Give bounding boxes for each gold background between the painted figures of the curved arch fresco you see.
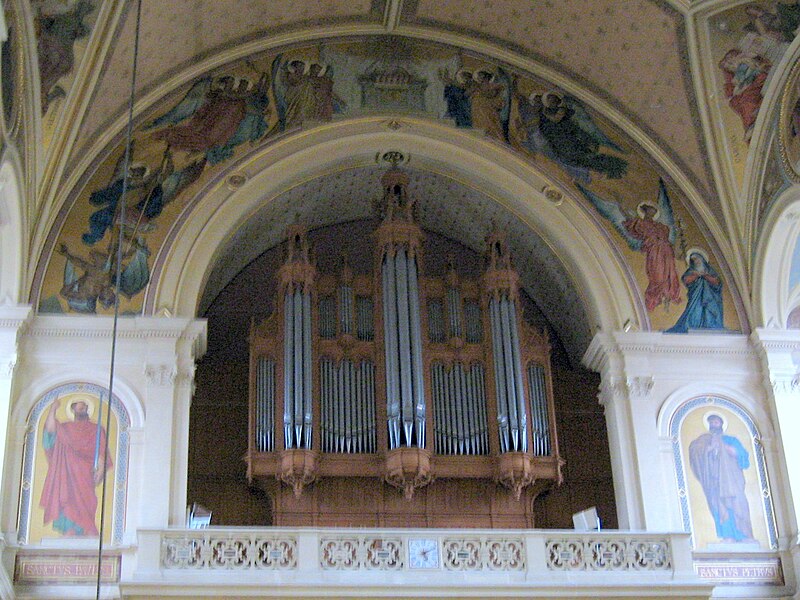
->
[38,38,740,330]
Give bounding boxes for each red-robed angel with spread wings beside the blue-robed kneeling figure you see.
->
[576,180,681,311]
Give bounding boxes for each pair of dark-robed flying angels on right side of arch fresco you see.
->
[536,92,628,180]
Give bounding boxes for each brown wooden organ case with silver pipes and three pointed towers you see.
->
[246,168,563,528]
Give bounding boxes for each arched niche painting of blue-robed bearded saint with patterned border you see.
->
[670,396,778,552]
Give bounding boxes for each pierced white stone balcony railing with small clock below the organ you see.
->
[126,527,710,598]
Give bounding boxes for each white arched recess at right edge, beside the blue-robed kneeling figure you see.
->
[753,185,800,329]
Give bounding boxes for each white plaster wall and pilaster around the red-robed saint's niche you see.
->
[0,316,205,560]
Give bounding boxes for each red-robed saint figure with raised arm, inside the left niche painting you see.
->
[39,396,113,536]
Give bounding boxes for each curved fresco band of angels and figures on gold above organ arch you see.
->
[37,36,740,340]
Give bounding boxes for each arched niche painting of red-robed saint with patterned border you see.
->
[18,383,130,544]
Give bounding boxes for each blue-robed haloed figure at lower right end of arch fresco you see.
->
[667,248,725,333]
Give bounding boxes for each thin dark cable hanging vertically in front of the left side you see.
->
[95,0,142,600]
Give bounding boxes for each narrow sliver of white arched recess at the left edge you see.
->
[0,147,27,303]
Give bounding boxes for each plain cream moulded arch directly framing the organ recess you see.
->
[150,117,649,342]
